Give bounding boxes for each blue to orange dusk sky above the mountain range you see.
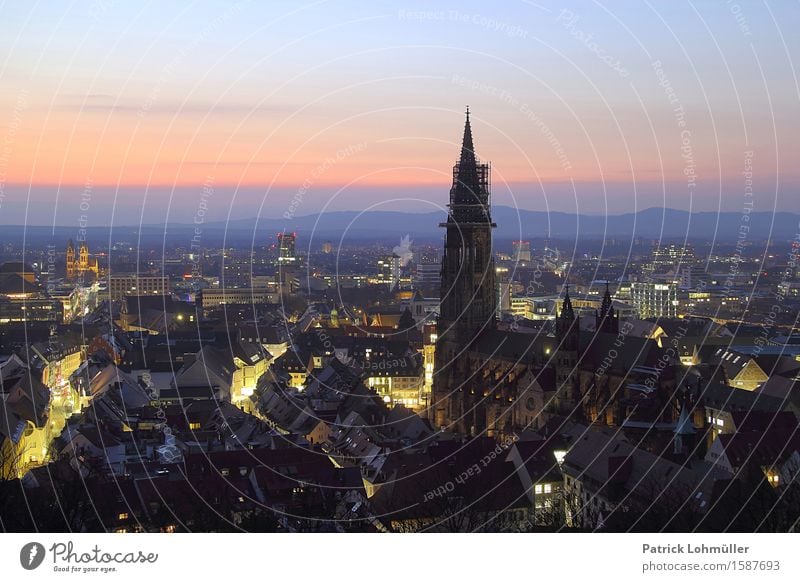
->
[0,0,800,226]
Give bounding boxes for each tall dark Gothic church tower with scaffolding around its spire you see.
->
[432,109,497,426]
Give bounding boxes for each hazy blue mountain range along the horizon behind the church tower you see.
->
[7,206,800,246]
